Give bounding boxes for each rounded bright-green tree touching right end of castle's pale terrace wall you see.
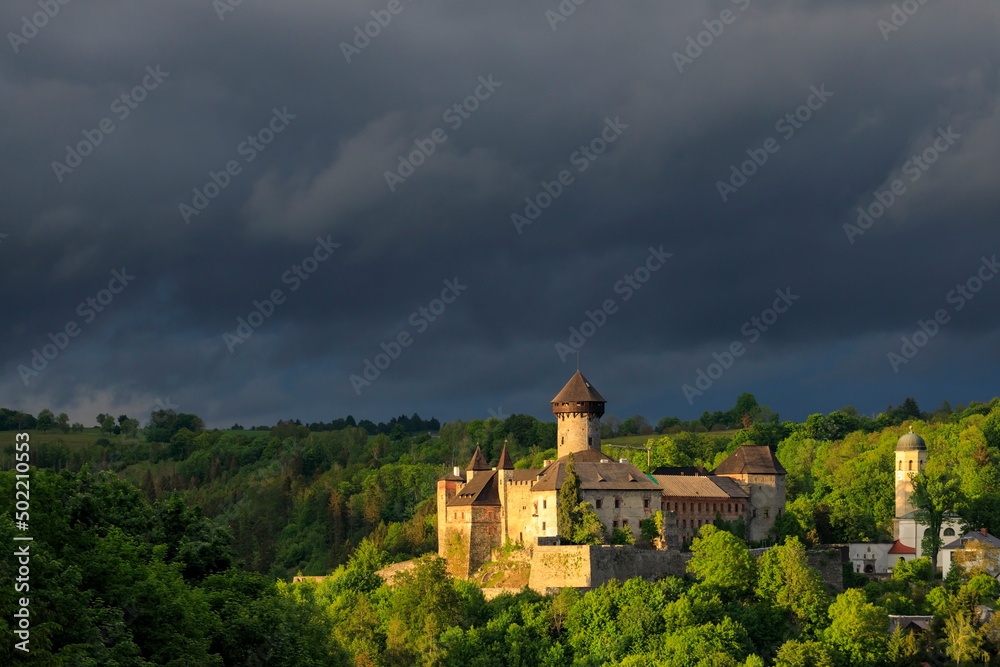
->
[687,525,757,599]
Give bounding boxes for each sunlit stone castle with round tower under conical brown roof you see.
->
[437,371,785,578]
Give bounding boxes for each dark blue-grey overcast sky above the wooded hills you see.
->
[0,0,1000,427]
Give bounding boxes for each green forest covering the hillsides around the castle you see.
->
[0,394,1000,667]
